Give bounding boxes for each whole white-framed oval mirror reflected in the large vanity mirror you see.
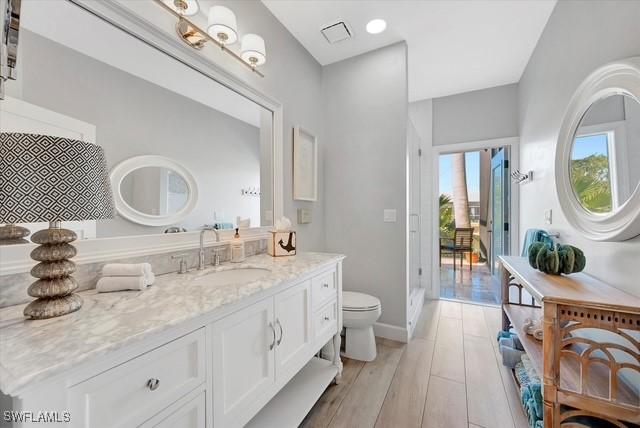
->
[111,155,198,226]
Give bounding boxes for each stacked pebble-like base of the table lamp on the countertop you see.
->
[23,223,82,319]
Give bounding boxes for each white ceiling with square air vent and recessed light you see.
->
[262,0,556,101]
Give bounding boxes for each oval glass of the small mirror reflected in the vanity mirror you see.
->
[119,166,189,216]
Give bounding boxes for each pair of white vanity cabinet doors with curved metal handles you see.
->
[212,280,326,427]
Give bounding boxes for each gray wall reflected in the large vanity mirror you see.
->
[20,30,262,237]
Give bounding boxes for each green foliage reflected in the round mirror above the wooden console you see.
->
[571,155,611,213]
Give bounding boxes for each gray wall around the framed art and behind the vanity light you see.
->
[210,0,326,251]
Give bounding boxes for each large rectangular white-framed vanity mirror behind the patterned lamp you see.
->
[2,0,282,247]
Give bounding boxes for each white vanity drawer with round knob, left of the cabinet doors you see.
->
[69,329,205,428]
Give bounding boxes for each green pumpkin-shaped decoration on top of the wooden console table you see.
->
[529,242,587,275]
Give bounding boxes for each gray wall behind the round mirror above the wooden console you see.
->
[518,1,640,295]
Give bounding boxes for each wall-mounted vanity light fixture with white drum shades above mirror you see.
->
[154,0,267,77]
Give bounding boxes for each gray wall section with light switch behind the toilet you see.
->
[323,43,408,328]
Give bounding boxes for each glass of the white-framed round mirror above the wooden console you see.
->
[569,94,640,215]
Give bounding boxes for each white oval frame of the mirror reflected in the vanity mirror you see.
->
[109,155,198,226]
